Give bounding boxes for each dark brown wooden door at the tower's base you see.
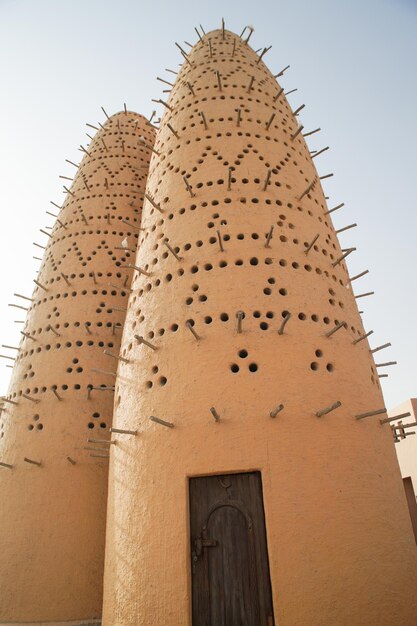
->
[190,472,274,626]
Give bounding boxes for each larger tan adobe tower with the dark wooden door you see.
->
[103,30,417,626]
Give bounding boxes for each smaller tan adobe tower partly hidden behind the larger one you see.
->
[0,111,154,624]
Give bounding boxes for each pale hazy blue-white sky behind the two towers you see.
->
[0,0,417,408]
